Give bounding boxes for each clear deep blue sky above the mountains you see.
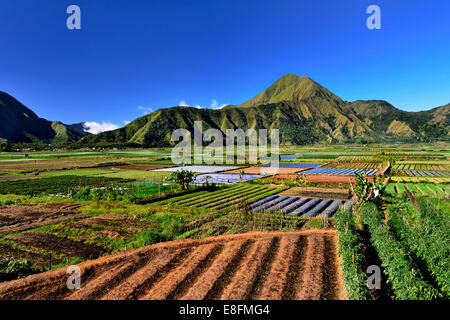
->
[0,0,450,132]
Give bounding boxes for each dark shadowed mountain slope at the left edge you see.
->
[0,91,88,144]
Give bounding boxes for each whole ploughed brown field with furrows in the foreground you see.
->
[0,230,343,300]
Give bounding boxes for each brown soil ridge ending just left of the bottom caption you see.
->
[141,244,218,300]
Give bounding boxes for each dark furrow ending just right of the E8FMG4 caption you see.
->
[281,235,307,300]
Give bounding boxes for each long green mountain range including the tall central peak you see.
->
[80,74,450,147]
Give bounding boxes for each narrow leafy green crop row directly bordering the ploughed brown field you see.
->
[335,210,374,300]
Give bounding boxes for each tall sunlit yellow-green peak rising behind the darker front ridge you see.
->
[238,73,340,108]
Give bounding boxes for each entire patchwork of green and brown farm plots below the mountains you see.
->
[0,145,450,300]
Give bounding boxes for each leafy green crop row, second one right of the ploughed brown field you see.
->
[362,202,442,300]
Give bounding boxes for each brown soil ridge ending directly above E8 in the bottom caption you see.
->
[220,237,274,300]
